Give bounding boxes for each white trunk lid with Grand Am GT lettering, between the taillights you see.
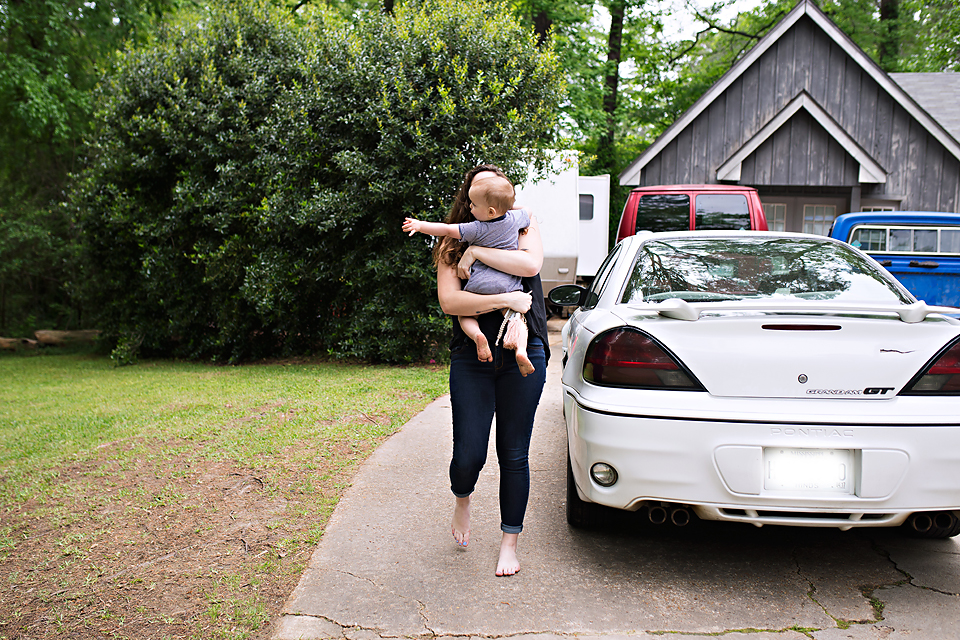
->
[635,314,956,400]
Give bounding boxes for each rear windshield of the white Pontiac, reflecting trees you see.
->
[622,237,912,304]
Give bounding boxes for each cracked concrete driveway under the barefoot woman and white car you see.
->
[271,324,960,640]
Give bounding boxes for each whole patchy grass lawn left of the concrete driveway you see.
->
[0,352,447,638]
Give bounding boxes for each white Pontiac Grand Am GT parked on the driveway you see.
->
[550,231,960,538]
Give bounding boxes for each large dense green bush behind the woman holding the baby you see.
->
[79,0,562,362]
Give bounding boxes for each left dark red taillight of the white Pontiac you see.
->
[583,328,704,391]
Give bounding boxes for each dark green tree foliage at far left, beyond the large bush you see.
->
[0,0,174,334]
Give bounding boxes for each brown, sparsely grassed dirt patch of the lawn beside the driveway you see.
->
[0,438,379,640]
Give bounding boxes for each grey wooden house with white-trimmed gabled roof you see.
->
[620,0,960,234]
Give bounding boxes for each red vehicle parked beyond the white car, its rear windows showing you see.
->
[617,184,767,242]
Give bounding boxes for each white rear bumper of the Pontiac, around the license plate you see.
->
[564,390,960,529]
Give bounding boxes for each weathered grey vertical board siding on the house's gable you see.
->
[640,16,960,211]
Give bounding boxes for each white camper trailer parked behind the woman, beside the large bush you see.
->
[516,152,610,295]
